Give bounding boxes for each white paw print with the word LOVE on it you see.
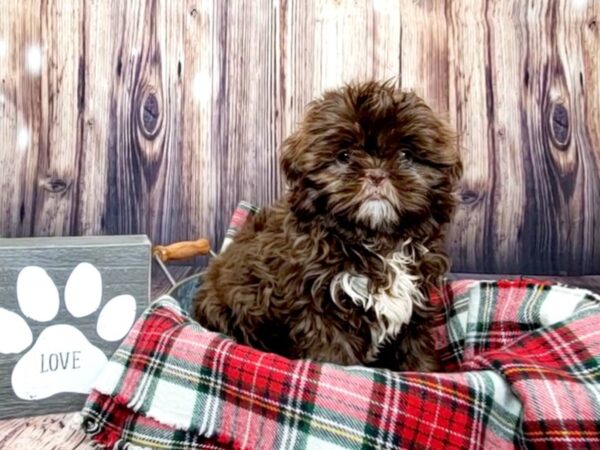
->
[0,262,136,400]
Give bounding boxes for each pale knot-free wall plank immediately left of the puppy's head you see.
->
[213,0,280,243]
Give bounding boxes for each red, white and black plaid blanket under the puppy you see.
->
[83,281,600,449]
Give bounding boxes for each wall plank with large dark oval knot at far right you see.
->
[519,1,600,273]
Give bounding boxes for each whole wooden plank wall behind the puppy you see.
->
[0,0,600,274]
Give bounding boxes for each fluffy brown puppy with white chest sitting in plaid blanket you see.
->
[194,82,462,371]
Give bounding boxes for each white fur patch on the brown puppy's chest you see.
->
[330,241,426,361]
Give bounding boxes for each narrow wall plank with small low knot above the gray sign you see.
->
[33,1,85,236]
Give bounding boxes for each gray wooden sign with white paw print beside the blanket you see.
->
[0,236,151,418]
